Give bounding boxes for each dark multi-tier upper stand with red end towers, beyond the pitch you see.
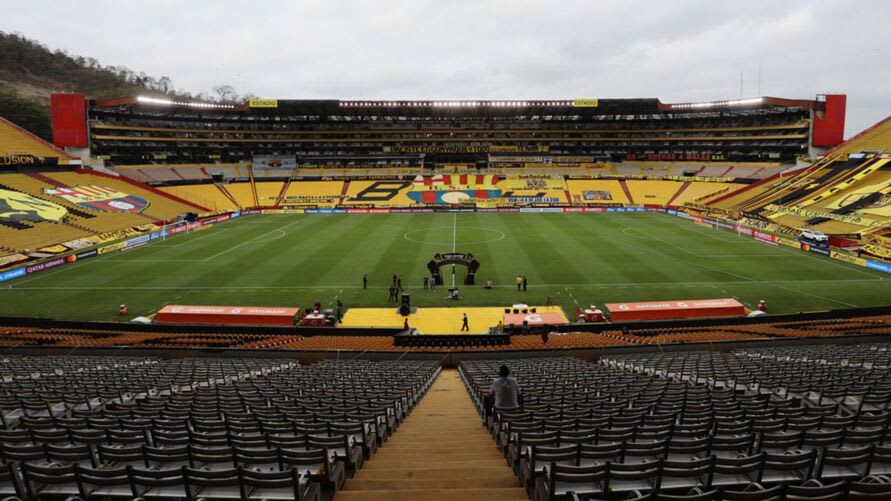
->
[45,95,846,167]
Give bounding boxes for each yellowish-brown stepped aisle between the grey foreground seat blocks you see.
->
[335,369,529,501]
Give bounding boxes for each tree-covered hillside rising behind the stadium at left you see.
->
[0,31,249,141]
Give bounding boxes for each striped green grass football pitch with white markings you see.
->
[0,213,891,320]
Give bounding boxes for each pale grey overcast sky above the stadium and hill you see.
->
[0,0,891,136]
